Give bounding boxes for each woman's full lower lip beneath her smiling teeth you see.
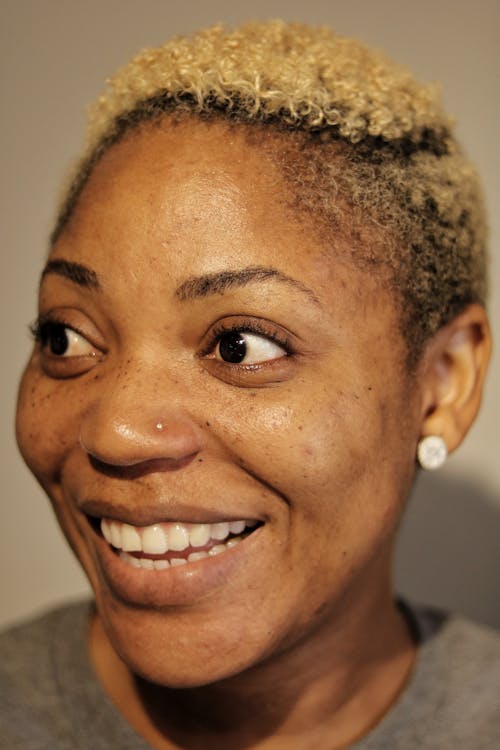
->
[91,527,263,607]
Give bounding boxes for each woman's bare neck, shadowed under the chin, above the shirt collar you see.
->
[90,568,415,750]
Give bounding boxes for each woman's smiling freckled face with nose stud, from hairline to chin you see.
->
[18,121,419,685]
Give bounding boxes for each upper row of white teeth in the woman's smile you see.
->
[101,518,256,555]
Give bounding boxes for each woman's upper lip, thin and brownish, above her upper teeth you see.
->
[78,499,263,526]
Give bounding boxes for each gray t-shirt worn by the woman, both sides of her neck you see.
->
[0,603,500,750]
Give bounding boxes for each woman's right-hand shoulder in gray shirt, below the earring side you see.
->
[353,602,500,750]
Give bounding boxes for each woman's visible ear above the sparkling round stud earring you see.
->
[421,305,491,452]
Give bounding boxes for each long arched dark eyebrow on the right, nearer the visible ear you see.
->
[175,266,320,305]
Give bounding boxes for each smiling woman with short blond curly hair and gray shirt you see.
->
[2,22,500,750]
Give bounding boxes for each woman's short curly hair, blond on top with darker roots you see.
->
[52,21,486,364]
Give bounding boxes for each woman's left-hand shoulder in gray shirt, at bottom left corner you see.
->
[0,602,148,750]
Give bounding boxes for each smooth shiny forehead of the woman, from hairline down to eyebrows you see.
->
[53,119,392,324]
